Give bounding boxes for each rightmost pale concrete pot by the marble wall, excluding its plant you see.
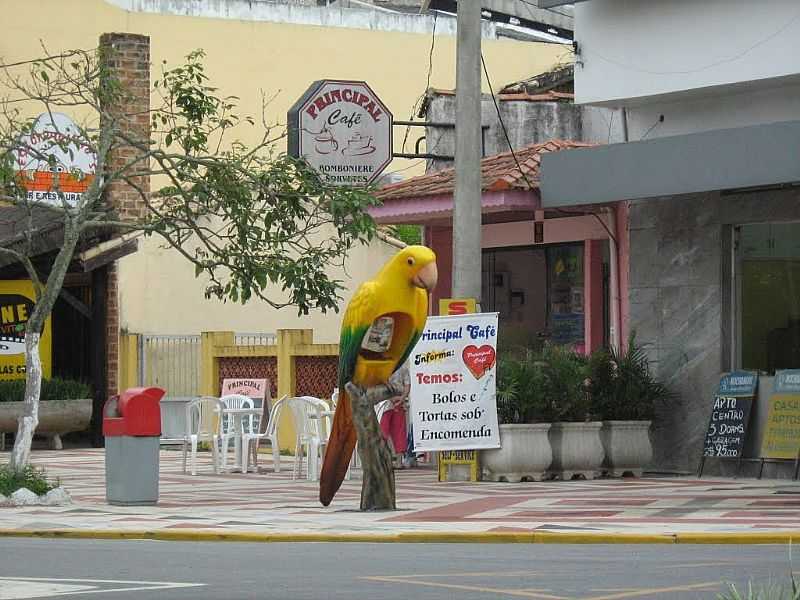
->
[600,421,653,477]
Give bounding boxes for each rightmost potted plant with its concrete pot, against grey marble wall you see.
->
[589,334,673,477]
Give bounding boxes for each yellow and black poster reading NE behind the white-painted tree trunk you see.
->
[0,280,52,381]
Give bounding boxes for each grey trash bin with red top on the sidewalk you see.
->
[103,387,165,506]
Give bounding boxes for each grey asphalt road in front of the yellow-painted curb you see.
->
[0,538,790,600]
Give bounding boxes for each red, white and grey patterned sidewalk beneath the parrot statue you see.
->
[0,449,800,542]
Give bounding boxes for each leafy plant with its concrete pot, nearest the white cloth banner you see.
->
[481,349,553,482]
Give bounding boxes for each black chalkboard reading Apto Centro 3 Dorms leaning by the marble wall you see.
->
[699,371,758,475]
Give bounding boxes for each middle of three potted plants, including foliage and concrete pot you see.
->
[542,345,603,480]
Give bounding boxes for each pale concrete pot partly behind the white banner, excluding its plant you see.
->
[481,423,553,483]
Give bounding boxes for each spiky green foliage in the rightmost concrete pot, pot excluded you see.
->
[589,333,674,421]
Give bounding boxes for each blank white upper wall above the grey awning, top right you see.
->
[575,0,800,106]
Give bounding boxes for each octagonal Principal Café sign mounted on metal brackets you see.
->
[287,79,392,186]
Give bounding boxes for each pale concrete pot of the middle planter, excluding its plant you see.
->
[549,421,605,481]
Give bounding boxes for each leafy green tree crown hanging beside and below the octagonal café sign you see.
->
[146,51,377,315]
